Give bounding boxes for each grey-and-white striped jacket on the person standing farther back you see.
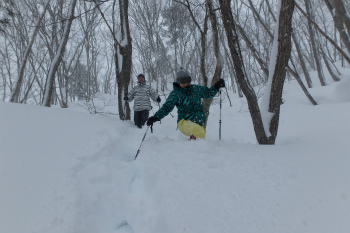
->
[128,82,158,111]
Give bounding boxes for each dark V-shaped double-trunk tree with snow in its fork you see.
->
[219,0,295,144]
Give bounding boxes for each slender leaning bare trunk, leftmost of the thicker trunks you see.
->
[10,0,50,103]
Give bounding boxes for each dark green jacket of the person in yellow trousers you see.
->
[154,82,218,126]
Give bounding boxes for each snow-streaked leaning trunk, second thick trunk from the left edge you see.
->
[43,0,77,107]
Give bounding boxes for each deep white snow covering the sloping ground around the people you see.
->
[0,71,350,233]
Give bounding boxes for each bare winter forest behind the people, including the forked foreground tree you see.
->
[0,0,350,144]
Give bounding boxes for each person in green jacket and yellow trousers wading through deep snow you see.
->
[147,67,225,139]
